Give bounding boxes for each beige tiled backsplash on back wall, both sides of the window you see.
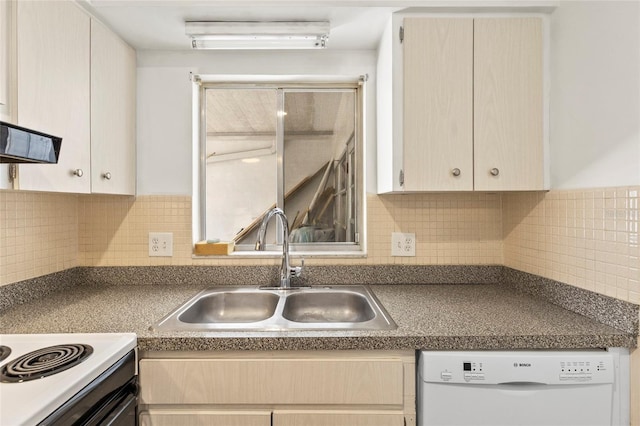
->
[78,194,502,266]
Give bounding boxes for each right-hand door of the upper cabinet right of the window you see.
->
[474,18,544,191]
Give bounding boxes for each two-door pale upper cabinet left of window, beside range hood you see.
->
[14,1,136,195]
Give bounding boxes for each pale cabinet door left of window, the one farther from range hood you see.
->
[91,20,136,195]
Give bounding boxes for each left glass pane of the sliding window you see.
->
[205,89,277,241]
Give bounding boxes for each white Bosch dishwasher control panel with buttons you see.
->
[419,350,614,384]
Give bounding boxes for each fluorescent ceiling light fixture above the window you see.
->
[185,21,329,49]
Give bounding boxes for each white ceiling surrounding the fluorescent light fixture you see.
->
[81,0,401,50]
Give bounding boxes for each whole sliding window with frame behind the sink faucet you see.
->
[194,76,364,254]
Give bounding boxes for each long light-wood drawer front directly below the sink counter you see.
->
[140,359,404,406]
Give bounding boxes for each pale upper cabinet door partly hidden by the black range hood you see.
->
[17,1,90,193]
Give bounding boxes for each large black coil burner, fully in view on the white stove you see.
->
[0,344,93,383]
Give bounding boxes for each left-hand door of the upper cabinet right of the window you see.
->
[403,18,473,191]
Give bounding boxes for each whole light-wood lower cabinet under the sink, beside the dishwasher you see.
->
[139,351,415,426]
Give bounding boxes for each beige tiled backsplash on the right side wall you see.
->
[502,186,640,304]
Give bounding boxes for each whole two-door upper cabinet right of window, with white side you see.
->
[378,15,549,193]
